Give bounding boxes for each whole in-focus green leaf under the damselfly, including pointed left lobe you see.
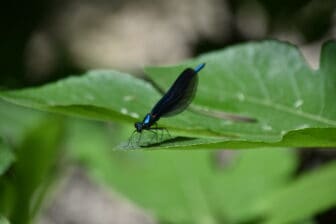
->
[1,41,336,148]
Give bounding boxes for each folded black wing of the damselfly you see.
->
[151,68,198,118]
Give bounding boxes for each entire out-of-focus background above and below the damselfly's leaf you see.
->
[0,0,336,224]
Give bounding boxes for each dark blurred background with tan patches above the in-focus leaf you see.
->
[0,0,336,88]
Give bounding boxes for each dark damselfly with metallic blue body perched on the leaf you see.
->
[134,63,205,133]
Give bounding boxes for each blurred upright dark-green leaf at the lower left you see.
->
[0,117,63,224]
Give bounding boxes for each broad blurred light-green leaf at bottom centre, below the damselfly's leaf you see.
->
[100,150,293,223]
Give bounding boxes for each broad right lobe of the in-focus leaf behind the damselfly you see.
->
[146,41,336,146]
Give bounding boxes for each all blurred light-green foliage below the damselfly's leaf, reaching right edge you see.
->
[68,121,336,224]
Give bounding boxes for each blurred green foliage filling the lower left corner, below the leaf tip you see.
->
[0,102,63,224]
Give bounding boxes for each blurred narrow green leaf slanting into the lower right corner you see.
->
[259,162,336,224]
